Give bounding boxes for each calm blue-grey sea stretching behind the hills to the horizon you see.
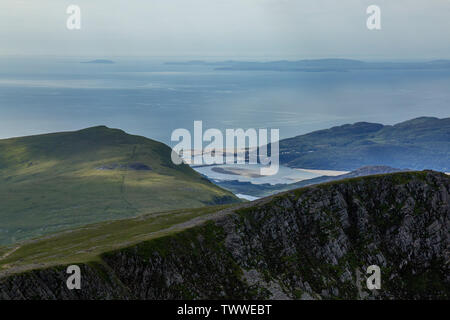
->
[0,58,450,145]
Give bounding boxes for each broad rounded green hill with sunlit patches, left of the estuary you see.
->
[0,126,238,244]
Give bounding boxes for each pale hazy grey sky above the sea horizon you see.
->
[0,0,450,59]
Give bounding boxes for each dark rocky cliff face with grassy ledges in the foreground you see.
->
[0,172,450,299]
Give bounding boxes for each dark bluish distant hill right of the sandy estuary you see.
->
[280,117,450,172]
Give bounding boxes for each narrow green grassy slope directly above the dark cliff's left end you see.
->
[0,205,229,271]
